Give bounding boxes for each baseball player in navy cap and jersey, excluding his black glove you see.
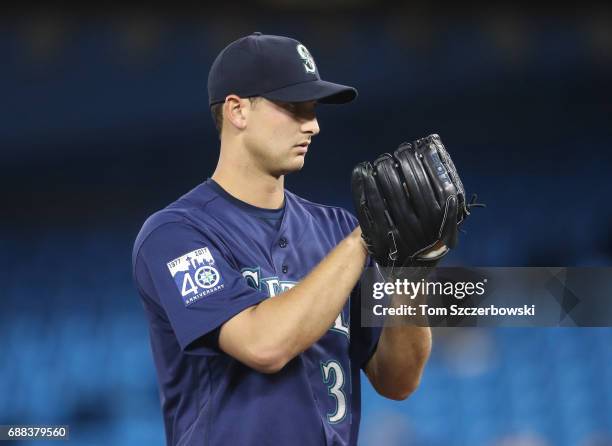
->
[132,33,431,446]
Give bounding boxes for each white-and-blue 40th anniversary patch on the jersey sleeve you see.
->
[167,247,225,306]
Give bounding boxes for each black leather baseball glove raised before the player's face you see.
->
[351,134,483,267]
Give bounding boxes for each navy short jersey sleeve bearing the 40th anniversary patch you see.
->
[134,222,268,354]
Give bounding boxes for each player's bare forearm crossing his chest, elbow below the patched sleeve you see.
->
[219,229,366,372]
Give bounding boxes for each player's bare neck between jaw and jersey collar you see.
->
[212,159,285,209]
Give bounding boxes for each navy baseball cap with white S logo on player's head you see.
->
[208,32,357,105]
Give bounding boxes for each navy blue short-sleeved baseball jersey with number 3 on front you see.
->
[132,180,380,446]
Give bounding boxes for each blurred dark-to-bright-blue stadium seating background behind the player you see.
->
[0,0,612,446]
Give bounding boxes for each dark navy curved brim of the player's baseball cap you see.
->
[261,80,357,104]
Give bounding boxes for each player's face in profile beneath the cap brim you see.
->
[244,98,319,177]
